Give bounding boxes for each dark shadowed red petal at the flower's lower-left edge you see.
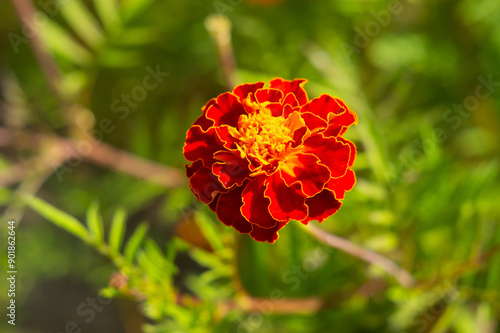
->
[216,187,252,234]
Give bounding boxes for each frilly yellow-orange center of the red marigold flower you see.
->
[231,102,293,175]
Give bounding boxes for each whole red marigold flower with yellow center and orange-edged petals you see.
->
[184,78,357,243]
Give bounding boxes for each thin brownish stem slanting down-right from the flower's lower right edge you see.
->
[305,224,416,288]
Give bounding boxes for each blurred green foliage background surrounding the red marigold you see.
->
[0,0,500,333]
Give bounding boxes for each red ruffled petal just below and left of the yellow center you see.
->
[212,151,249,188]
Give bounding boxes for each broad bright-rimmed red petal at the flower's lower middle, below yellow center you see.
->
[264,172,307,221]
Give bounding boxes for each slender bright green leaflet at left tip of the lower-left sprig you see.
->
[23,196,90,242]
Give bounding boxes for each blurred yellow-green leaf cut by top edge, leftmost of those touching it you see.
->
[60,0,103,49]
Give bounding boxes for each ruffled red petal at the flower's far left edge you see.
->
[184,125,224,167]
